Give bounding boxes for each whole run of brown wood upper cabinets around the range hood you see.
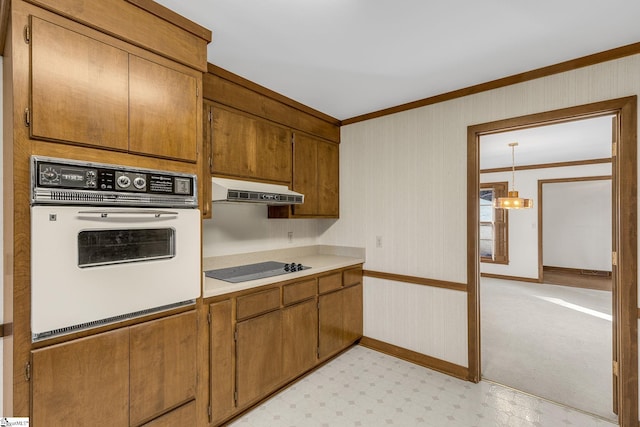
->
[203,64,340,218]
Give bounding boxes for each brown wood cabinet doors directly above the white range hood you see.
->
[205,106,291,185]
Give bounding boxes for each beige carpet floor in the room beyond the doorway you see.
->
[480,278,617,420]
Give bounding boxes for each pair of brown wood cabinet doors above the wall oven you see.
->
[27,16,202,162]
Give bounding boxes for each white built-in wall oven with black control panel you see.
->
[31,156,202,341]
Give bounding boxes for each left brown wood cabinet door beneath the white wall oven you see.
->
[31,328,129,427]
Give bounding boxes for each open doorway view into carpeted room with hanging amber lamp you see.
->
[480,116,617,421]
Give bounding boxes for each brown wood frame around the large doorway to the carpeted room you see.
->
[467,96,639,427]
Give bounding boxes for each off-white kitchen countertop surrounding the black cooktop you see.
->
[202,245,365,298]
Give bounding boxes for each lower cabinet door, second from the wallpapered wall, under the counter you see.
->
[318,290,344,359]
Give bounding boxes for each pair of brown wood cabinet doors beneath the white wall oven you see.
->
[31,311,196,427]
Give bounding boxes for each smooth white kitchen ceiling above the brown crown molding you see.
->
[156,0,640,119]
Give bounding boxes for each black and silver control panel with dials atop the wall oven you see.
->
[31,156,197,206]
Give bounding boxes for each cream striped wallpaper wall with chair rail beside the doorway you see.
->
[319,55,640,374]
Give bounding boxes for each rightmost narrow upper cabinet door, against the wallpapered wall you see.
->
[316,141,340,217]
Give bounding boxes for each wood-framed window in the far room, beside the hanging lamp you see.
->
[480,182,509,264]
